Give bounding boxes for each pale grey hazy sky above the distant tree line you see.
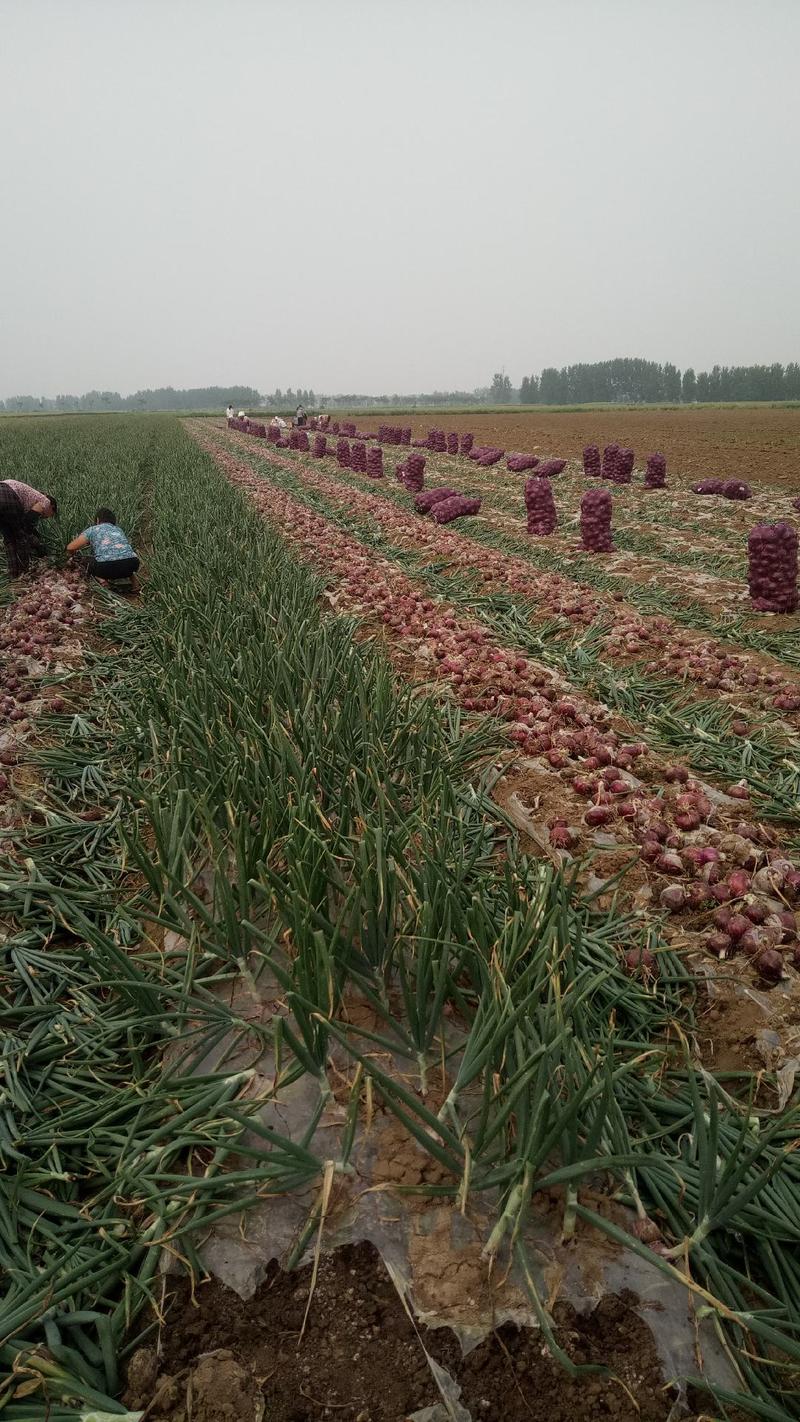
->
[0,0,800,397]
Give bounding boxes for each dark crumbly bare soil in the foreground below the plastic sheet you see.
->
[125,1244,744,1422]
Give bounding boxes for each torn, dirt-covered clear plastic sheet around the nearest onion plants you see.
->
[163,970,737,1422]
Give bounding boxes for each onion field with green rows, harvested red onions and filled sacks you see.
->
[0,412,800,1422]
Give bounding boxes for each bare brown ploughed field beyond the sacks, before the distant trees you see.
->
[335,405,800,493]
